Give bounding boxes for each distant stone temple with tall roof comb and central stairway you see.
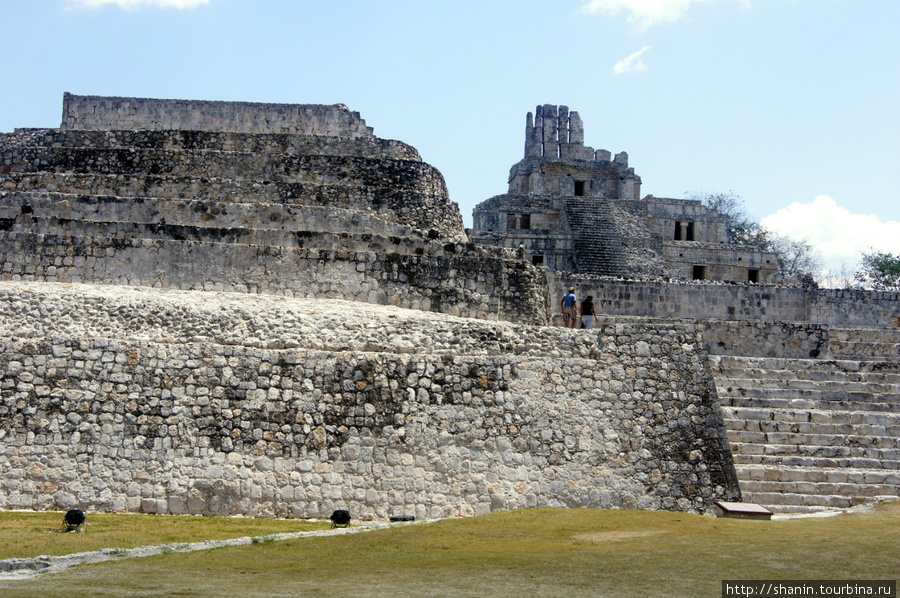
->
[473,105,776,282]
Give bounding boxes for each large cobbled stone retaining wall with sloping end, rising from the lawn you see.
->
[0,283,739,519]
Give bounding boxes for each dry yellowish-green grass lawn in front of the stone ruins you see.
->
[0,503,900,598]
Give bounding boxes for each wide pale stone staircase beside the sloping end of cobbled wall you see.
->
[710,344,900,513]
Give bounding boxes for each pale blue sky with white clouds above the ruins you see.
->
[0,0,900,274]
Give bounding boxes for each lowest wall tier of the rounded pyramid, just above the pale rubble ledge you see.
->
[0,232,547,324]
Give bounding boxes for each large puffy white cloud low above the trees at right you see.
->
[760,195,900,271]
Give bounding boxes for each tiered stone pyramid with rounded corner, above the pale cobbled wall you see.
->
[0,94,546,322]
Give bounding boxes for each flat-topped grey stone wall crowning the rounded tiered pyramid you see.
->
[61,93,372,137]
